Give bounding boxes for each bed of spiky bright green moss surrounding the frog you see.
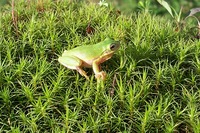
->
[0,0,200,133]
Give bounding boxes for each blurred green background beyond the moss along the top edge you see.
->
[0,0,200,14]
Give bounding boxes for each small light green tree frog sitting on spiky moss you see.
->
[58,38,120,80]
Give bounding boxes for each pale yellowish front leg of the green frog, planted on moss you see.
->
[92,58,106,80]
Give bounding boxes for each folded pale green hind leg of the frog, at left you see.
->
[58,56,89,80]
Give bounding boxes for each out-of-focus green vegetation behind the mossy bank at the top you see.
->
[0,0,200,16]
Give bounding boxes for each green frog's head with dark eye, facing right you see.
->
[104,38,120,54]
